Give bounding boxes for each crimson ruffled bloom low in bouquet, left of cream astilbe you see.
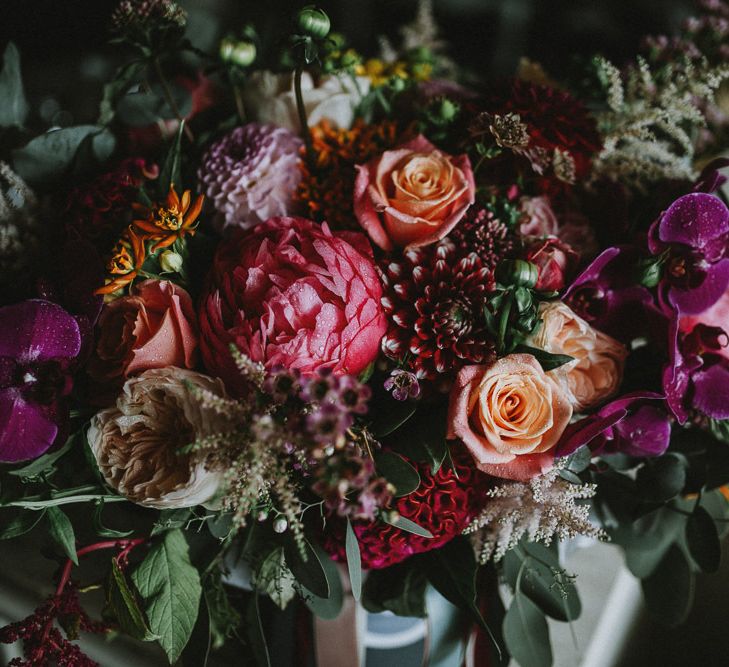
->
[324,452,489,570]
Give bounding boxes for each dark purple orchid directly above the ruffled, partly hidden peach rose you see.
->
[563,247,660,343]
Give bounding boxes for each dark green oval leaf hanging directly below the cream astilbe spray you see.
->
[503,542,582,621]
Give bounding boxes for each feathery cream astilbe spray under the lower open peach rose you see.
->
[463,467,606,564]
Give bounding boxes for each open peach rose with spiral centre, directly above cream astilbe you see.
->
[448,354,572,481]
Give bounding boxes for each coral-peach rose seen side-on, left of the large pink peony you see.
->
[89,280,197,385]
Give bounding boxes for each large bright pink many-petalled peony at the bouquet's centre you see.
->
[200,217,387,391]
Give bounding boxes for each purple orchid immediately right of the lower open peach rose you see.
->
[557,392,671,456]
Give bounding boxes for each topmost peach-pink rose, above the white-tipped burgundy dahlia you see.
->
[354,135,476,251]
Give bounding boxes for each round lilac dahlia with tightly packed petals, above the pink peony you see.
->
[198,123,302,229]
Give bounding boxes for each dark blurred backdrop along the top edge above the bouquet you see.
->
[0,0,693,125]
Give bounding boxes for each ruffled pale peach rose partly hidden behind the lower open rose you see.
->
[529,301,628,410]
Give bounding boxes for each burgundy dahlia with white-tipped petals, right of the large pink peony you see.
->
[381,239,494,380]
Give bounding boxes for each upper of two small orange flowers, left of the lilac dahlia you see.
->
[132,184,205,254]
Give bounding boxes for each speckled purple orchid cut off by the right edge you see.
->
[648,192,729,315]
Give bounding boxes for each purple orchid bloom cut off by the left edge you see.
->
[0,299,81,463]
